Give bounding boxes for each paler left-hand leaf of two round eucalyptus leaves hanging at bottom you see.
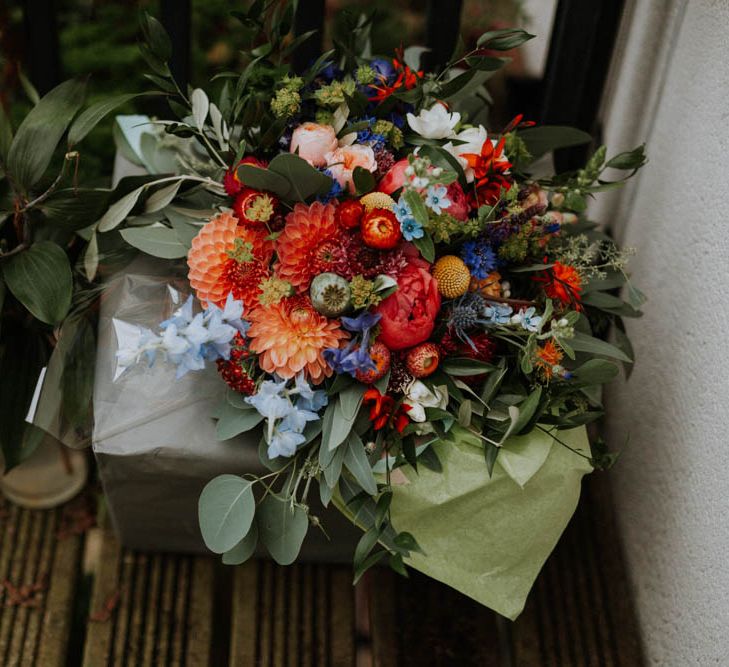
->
[198,475,256,554]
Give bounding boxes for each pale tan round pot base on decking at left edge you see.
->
[0,436,89,509]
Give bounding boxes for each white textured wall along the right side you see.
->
[594,0,729,667]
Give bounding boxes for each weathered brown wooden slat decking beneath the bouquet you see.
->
[0,476,643,667]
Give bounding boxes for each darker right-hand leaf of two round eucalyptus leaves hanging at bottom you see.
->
[256,495,309,565]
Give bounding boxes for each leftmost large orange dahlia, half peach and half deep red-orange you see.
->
[187,213,273,308]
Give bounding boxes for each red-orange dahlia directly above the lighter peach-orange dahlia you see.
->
[276,202,342,292]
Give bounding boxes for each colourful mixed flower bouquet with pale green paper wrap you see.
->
[105,3,644,617]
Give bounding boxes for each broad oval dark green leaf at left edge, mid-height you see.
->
[3,241,73,324]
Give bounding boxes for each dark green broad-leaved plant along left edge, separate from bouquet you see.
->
[0,80,145,471]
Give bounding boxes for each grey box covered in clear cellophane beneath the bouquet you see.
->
[93,261,359,562]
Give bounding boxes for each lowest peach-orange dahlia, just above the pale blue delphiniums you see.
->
[248,296,347,384]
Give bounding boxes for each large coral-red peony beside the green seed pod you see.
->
[377,260,440,350]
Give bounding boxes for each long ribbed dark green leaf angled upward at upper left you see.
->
[7,80,85,190]
